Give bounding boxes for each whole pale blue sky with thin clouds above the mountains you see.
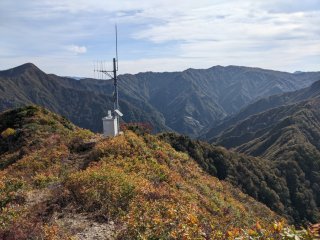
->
[0,0,320,77]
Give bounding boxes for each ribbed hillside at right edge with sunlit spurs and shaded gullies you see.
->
[213,98,320,223]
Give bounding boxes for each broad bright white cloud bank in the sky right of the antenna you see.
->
[122,1,320,71]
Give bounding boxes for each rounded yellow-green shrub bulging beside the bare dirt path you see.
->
[65,165,135,218]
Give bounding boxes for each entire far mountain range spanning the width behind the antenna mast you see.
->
[0,64,320,136]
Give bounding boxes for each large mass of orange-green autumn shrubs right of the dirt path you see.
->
[64,131,288,239]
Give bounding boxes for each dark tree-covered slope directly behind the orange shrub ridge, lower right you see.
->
[159,133,320,224]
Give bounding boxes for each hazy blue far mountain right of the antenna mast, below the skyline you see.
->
[116,66,320,136]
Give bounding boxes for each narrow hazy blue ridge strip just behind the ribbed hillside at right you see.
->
[202,81,320,139]
